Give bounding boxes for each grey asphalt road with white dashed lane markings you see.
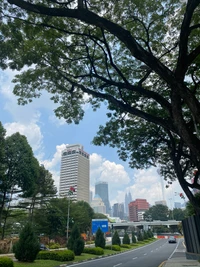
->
[70,239,183,267]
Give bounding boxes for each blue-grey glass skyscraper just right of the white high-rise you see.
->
[95,182,110,214]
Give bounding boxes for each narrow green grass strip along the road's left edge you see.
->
[14,239,155,267]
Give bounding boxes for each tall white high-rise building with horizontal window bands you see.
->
[59,144,90,203]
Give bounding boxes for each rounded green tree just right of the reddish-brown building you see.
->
[144,204,169,221]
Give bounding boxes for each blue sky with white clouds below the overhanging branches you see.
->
[0,69,187,209]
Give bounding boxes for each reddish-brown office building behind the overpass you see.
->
[128,199,149,222]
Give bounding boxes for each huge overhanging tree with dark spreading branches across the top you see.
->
[0,0,200,213]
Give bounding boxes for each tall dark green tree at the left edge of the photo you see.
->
[0,129,39,239]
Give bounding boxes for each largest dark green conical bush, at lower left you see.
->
[13,223,40,262]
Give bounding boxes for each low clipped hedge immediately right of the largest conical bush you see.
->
[37,250,75,261]
